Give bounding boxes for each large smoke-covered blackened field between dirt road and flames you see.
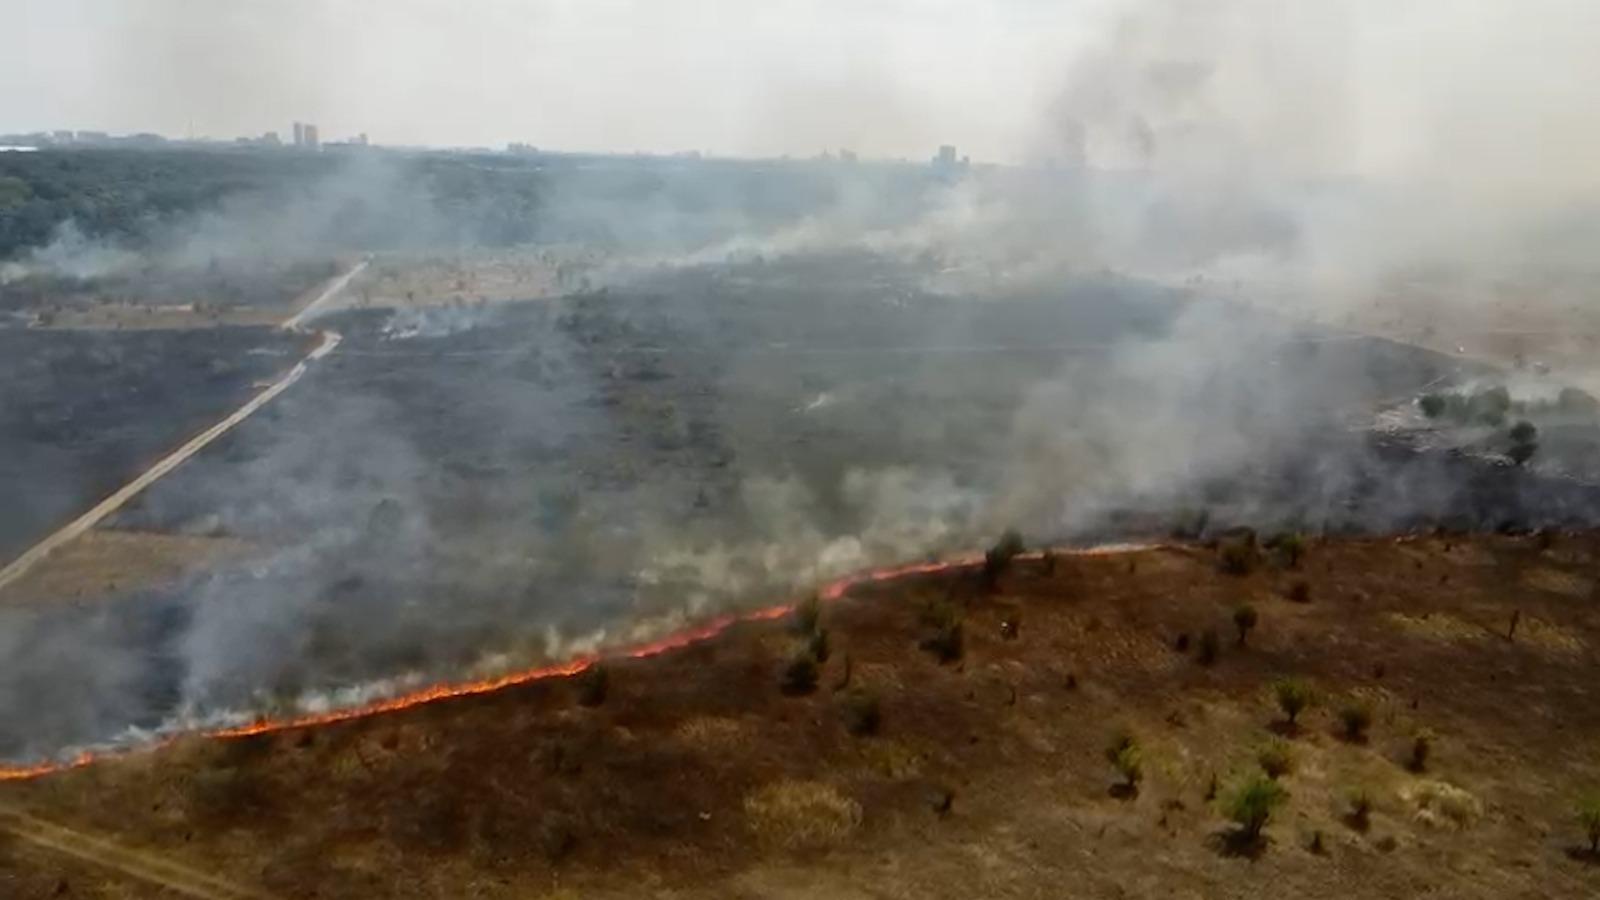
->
[9,255,1600,759]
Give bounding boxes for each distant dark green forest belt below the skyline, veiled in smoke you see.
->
[0,147,930,259]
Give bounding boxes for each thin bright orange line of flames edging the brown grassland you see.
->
[0,544,1158,781]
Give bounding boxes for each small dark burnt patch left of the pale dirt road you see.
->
[0,321,306,560]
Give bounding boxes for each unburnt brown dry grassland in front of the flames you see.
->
[0,532,1600,898]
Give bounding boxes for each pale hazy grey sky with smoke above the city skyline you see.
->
[9,0,1600,183]
